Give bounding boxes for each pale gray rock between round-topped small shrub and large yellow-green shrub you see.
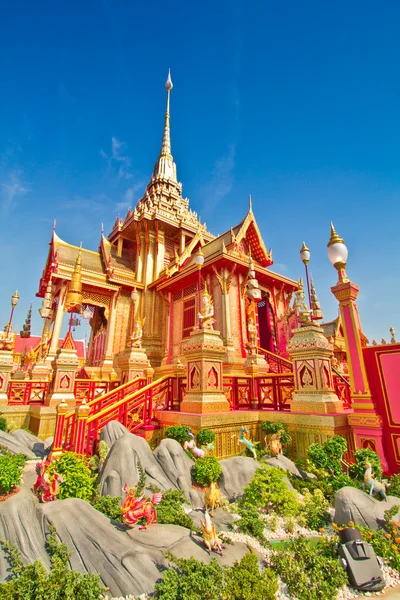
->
[218,456,261,501]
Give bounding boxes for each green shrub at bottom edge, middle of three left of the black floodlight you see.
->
[223,552,278,600]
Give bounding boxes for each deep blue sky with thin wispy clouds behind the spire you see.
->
[0,0,400,340]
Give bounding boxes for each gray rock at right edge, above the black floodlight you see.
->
[334,487,400,530]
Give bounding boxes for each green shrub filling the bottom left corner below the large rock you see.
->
[0,525,106,600]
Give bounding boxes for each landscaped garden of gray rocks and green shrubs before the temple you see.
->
[0,423,400,600]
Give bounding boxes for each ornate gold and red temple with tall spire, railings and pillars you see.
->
[0,70,400,470]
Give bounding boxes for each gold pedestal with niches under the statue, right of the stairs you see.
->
[180,329,230,414]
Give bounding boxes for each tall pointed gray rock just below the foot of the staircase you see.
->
[99,431,176,496]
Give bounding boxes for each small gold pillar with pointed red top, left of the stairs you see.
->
[45,331,79,406]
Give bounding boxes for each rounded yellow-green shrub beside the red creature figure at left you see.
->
[48,452,94,502]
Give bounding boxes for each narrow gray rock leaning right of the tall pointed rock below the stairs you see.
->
[153,439,204,508]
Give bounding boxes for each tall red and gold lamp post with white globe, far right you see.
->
[328,223,388,471]
